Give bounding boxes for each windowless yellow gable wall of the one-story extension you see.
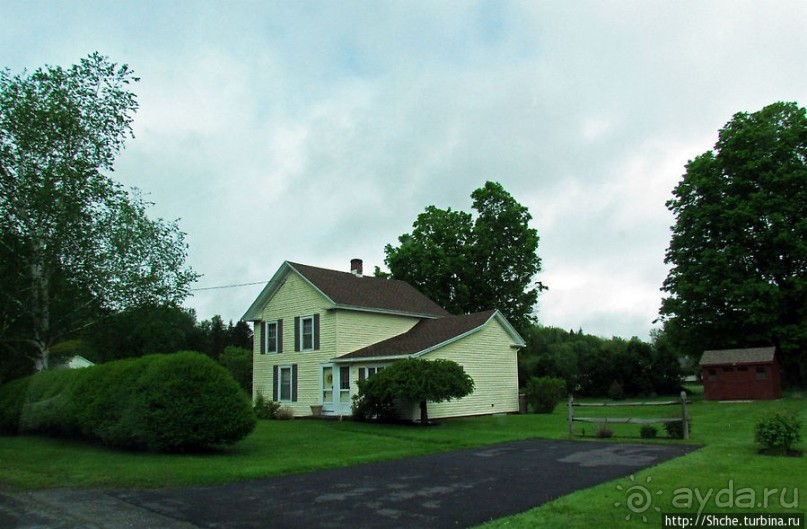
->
[412,318,518,419]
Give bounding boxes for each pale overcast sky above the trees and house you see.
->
[0,0,807,339]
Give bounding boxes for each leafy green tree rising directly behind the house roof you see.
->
[384,182,545,330]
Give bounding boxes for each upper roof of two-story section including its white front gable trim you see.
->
[241,261,449,321]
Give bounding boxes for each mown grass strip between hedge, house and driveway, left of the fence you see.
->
[0,415,565,490]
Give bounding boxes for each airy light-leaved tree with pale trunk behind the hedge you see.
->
[0,53,197,368]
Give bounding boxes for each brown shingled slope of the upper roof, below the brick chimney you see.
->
[289,263,450,316]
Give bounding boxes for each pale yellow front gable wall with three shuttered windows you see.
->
[252,272,336,416]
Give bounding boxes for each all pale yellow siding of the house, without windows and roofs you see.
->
[253,270,518,419]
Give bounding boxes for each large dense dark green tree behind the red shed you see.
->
[661,103,807,383]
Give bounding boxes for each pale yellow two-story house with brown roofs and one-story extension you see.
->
[242,259,524,419]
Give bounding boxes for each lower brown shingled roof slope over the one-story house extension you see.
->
[338,310,496,360]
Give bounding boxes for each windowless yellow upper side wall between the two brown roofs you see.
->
[336,310,420,355]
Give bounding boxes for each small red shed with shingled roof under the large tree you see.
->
[700,347,782,400]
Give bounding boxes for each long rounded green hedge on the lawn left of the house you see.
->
[0,351,256,452]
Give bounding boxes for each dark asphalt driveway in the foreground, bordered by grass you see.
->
[0,439,697,529]
